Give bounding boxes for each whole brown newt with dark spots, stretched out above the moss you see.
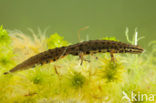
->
[4,40,143,74]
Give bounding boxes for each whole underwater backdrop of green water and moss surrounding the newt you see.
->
[0,0,156,103]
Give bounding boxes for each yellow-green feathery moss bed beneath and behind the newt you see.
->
[0,29,156,103]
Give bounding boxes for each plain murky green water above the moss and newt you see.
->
[0,0,156,47]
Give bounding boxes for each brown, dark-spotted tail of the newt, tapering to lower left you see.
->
[4,47,67,74]
